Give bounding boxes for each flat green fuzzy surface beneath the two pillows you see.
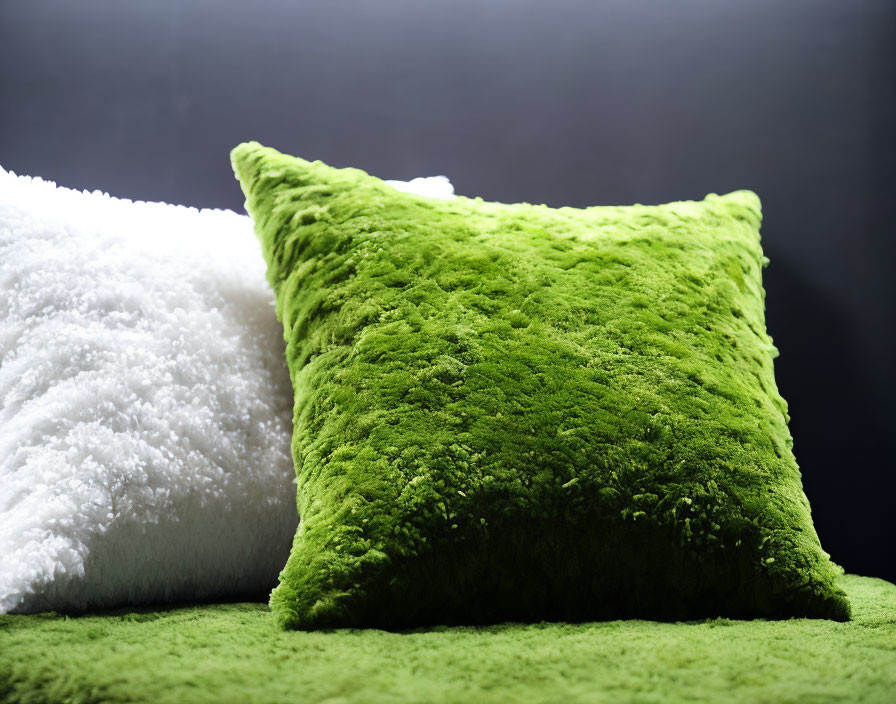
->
[0,576,896,704]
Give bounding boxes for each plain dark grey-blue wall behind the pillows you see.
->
[0,0,896,580]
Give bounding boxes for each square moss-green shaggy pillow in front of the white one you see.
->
[232,143,849,629]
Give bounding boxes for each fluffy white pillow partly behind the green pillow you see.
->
[0,169,452,613]
